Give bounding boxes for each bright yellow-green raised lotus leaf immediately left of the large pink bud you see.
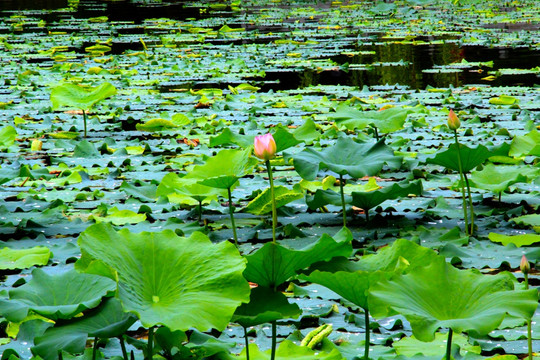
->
[184,149,257,189]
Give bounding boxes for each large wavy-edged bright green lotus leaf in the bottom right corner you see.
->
[368,258,538,341]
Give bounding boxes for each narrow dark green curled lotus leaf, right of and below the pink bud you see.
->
[349,179,422,211]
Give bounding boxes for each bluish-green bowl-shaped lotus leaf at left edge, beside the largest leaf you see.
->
[4,269,116,321]
